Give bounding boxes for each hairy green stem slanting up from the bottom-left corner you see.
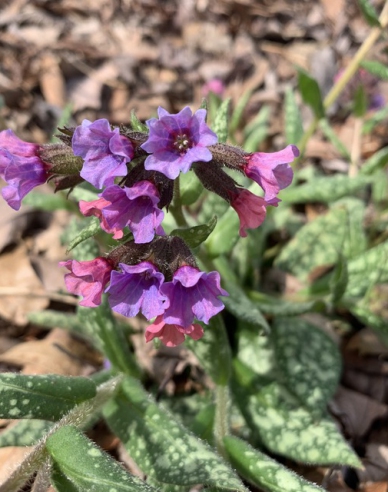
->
[0,376,122,492]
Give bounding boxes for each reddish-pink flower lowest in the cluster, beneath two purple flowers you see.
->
[145,316,203,347]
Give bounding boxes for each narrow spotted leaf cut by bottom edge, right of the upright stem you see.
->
[224,436,323,492]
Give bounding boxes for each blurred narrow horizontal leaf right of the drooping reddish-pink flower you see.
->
[282,174,368,203]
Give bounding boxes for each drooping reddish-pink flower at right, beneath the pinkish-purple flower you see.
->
[231,188,272,237]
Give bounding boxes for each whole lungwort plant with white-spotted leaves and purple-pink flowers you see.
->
[0,1,388,492]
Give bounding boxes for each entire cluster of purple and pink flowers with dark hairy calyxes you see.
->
[0,107,298,346]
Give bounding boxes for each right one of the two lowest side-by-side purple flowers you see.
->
[160,265,228,329]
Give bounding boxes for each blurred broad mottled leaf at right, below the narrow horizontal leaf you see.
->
[275,198,366,281]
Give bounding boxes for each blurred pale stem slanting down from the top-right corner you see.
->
[296,0,388,158]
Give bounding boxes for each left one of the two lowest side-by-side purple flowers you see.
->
[106,261,166,320]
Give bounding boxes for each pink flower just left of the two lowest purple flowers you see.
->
[59,257,113,307]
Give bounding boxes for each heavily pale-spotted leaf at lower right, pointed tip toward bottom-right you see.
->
[239,383,362,467]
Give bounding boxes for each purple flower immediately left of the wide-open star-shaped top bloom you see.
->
[72,119,134,188]
